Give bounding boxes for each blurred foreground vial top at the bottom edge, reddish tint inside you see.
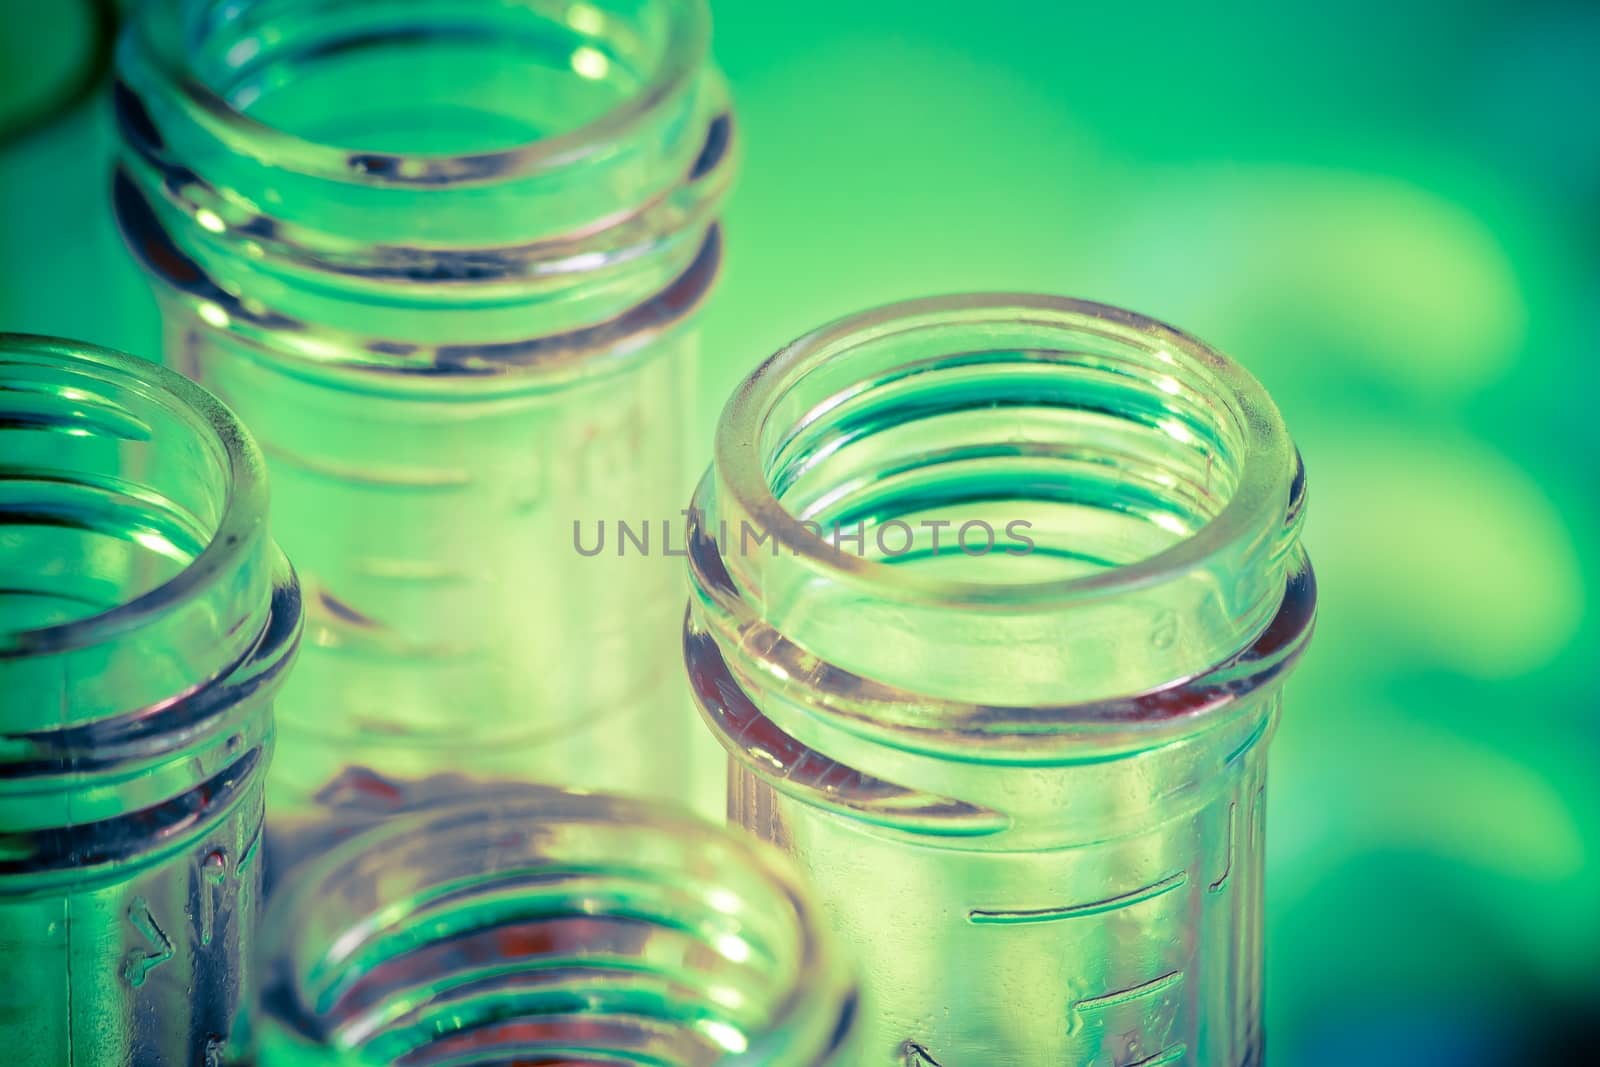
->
[262,785,856,1067]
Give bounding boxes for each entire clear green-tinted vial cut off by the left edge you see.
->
[0,334,299,1067]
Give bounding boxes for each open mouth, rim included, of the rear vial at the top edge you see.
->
[130,0,709,187]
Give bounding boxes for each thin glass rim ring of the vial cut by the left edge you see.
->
[0,333,267,657]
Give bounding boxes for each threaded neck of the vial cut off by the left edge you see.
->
[0,334,299,877]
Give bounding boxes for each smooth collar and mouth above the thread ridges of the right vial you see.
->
[698,298,1304,709]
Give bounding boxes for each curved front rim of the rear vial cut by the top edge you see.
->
[128,0,710,187]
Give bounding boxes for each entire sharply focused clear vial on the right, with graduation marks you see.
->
[685,296,1315,1067]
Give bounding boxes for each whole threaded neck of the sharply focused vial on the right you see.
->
[685,294,1315,848]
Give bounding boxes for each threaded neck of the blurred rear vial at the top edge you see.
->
[115,0,731,383]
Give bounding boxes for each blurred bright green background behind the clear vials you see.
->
[0,0,1600,1067]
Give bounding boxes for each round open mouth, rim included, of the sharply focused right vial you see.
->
[715,294,1298,609]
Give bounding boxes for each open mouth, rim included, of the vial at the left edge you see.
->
[0,334,267,659]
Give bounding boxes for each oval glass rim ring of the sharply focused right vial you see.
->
[712,291,1294,608]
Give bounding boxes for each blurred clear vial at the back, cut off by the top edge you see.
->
[114,0,731,838]
